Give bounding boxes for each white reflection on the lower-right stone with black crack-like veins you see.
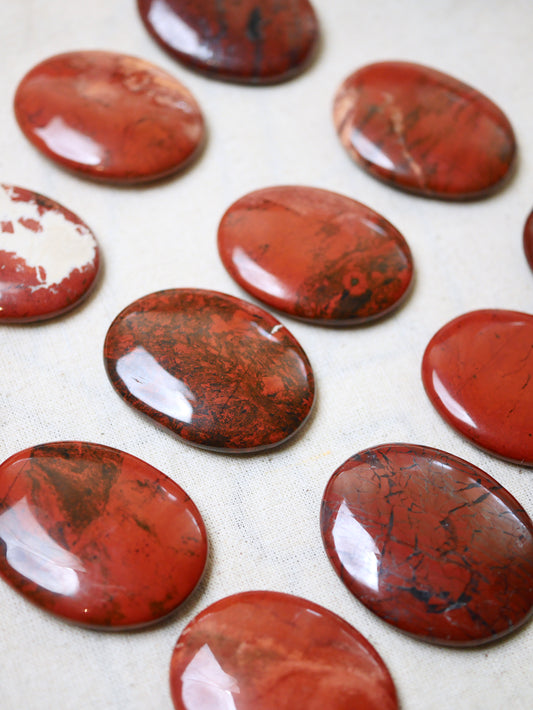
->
[333,500,380,591]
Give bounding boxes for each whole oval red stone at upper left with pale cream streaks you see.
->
[15,51,204,183]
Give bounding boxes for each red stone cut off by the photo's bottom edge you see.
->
[170,592,398,710]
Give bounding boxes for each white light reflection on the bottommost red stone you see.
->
[181,644,240,710]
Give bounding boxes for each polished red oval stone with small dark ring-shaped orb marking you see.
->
[218,186,413,325]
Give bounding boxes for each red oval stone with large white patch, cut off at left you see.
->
[0,185,99,323]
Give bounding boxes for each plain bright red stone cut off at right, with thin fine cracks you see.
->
[422,310,533,466]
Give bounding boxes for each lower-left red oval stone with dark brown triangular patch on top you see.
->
[0,441,207,629]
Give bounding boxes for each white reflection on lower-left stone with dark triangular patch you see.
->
[0,498,84,596]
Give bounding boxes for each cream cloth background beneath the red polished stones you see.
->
[0,0,533,710]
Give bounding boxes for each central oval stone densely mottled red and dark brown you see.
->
[104,289,314,452]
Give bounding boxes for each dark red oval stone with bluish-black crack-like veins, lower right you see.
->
[320,444,533,646]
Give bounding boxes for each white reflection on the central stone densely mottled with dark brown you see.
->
[117,346,196,424]
